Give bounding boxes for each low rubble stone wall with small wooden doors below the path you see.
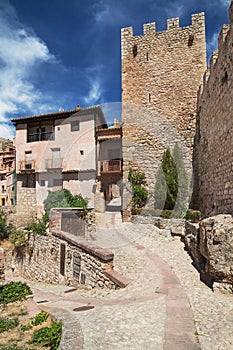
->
[12,231,116,288]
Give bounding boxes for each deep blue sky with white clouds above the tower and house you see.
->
[0,0,230,138]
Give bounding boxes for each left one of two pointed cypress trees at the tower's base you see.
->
[155,148,179,210]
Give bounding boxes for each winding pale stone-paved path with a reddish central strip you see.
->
[6,213,233,350]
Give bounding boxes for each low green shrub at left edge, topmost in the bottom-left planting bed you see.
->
[0,282,32,304]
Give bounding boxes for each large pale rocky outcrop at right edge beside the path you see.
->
[184,214,233,292]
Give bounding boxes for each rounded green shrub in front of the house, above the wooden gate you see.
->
[44,189,88,215]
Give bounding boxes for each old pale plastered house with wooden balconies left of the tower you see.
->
[12,106,121,223]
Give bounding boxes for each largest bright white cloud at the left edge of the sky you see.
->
[0,3,55,125]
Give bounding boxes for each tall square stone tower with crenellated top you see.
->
[121,13,206,217]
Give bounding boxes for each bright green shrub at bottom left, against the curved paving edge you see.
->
[32,322,62,350]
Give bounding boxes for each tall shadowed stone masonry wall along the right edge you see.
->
[193,2,233,217]
